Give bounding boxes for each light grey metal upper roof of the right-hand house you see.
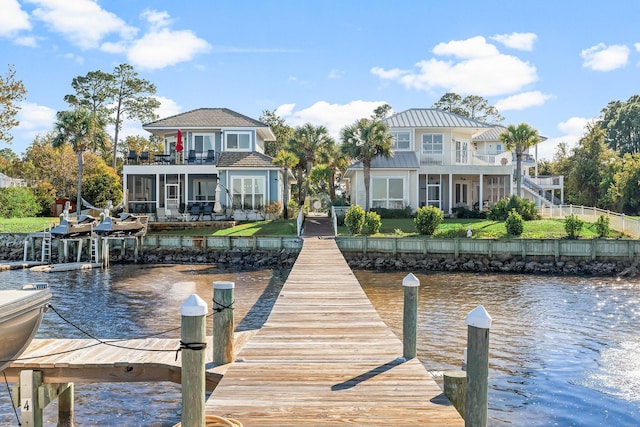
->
[383,108,491,129]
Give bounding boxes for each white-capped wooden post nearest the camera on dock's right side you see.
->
[464,305,491,427]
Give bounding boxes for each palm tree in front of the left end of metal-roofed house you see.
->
[341,119,393,211]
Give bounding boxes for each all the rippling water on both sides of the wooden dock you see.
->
[0,265,640,427]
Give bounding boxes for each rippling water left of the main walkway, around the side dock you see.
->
[0,265,288,427]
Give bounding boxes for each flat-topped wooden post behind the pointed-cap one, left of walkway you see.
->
[213,282,235,365]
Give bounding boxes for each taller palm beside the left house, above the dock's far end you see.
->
[288,123,335,202]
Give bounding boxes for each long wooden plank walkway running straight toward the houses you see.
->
[206,238,464,426]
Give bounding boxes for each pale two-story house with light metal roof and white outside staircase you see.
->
[344,108,561,214]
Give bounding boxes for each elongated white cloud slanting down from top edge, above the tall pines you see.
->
[30,0,137,49]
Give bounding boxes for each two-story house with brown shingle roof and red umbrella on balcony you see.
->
[123,108,283,220]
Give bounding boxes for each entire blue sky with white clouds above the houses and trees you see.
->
[0,0,640,158]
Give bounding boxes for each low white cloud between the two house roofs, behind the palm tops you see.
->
[275,101,385,142]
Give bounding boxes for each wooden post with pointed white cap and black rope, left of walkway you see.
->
[180,294,209,427]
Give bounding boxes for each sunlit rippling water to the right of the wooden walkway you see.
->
[356,271,640,426]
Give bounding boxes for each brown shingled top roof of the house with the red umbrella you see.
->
[142,108,268,130]
